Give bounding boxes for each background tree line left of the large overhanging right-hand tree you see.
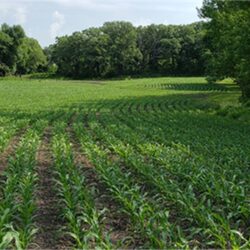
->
[0,21,204,78]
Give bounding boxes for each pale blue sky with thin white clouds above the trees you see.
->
[0,0,202,47]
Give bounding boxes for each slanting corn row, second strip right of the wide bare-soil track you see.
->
[74,121,186,248]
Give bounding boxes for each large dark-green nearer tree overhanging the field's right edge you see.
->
[200,0,250,98]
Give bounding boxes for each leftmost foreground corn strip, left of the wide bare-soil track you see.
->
[0,121,46,249]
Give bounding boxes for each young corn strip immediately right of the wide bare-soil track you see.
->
[52,121,111,249]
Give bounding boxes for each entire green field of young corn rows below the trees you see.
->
[0,78,250,249]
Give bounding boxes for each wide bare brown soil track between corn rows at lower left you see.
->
[34,127,69,249]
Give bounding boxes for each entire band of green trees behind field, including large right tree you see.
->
[0,0,250,99]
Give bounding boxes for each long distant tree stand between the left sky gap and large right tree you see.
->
[46,22,205,78]
